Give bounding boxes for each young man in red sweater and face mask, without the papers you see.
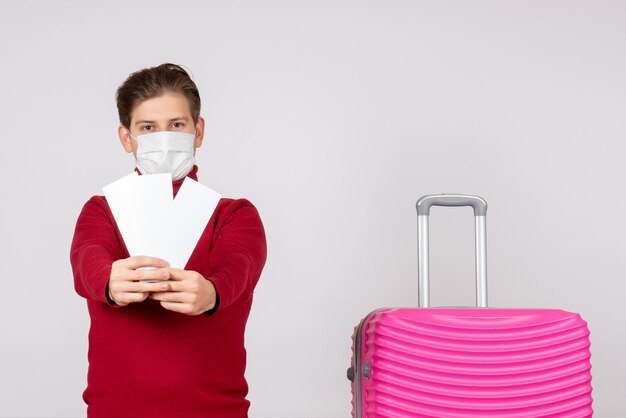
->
[70,64,266,418]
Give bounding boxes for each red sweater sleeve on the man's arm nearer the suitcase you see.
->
[207,199,267,310]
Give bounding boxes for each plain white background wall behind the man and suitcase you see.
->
[0,0,626,418]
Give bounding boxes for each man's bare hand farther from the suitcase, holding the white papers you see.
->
[108,255,170,306]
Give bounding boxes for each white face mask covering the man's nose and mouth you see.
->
[129,131,196,180]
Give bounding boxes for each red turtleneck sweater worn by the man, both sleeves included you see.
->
[70,167,267,418]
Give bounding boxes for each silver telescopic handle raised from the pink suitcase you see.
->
[415,194,487,308]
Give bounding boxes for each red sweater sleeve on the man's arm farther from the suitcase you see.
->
[70,196,124,306]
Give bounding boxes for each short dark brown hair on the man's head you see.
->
[115,63,200,128]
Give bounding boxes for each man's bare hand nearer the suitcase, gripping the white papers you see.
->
[149,268,216,315]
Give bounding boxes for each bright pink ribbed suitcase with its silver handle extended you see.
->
[348,195,593,418]
